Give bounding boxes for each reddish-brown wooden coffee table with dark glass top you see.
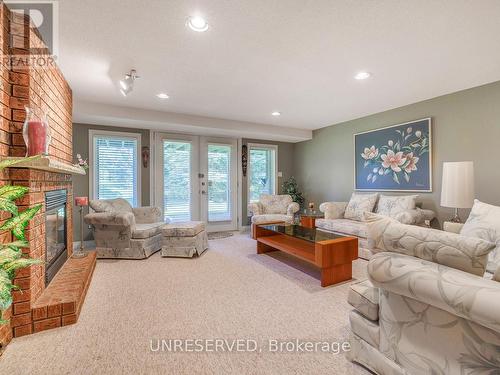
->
[255,224,358,287]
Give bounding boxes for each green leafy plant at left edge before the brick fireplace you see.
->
[0,156,42,324]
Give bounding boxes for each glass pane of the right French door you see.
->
[208,144,231,222]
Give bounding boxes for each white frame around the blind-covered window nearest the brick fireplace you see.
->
[89,129,142,207]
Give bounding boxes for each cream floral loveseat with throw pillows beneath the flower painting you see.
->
[316,193,436,259]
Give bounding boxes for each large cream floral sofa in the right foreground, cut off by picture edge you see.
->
[348,217,500,375]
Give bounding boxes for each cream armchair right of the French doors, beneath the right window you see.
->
[248,194,300,235]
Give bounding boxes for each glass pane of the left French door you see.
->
[163,141,191,221]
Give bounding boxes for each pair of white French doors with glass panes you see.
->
[153,133,238,231]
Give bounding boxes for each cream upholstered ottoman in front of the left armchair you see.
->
[161,221,208,258]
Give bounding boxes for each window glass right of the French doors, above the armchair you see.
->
[248,147,276,202]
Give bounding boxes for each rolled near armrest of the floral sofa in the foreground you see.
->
[368,252,500,332]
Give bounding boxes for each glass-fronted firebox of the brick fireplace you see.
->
[45,190,68,286]
